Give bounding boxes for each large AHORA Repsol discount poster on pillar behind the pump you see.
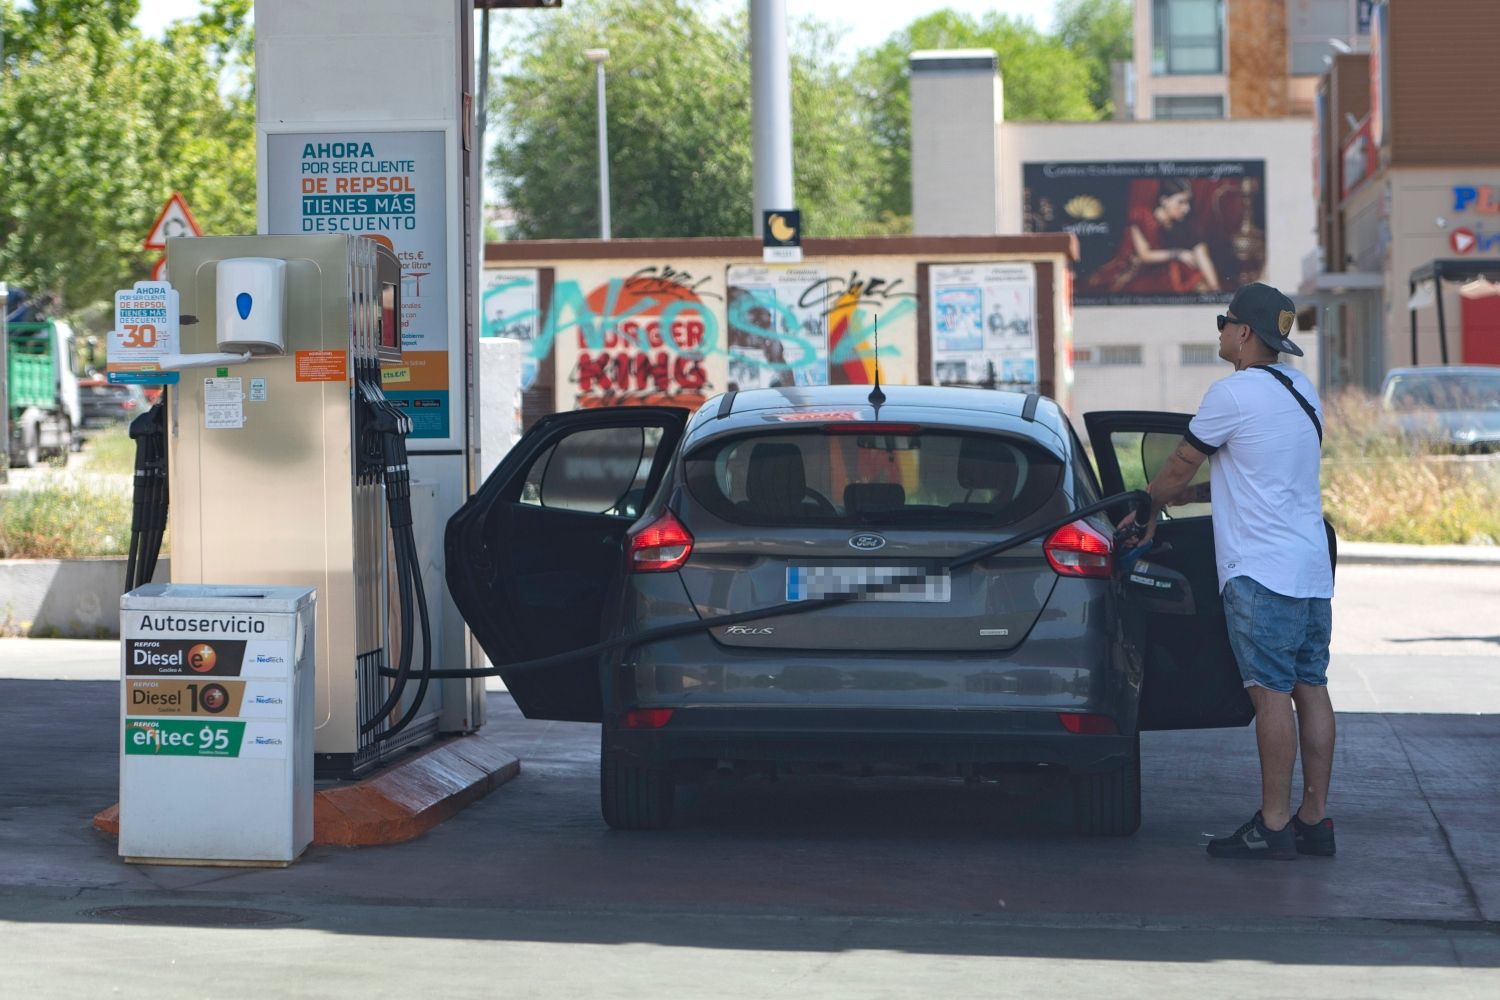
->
[266,132,453,438]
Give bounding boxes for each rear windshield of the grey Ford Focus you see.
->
[686,430,1062,526]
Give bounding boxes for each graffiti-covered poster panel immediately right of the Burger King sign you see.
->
[728,265,828,390]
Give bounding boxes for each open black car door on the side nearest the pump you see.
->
[444,406,689,723]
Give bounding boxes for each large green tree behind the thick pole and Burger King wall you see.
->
[492,0,881,238]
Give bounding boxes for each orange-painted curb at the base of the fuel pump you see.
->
[93,730,521,847]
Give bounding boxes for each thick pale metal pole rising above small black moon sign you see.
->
[750,0,797,235]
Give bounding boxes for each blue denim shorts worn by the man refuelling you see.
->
[1224,576,1334,694]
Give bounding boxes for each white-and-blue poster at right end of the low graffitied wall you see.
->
[927,264,1037,387]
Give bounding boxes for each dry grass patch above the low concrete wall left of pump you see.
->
[0,480,131,559]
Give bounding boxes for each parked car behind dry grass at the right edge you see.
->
[1380,364,1500,451]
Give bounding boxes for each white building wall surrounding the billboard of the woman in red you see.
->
[998,118,1317,414]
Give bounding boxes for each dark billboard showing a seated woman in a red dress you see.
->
[1022,160,1266,306]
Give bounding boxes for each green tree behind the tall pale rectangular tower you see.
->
[855,10,1098,217]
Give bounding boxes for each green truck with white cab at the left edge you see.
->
[5,319,83,468]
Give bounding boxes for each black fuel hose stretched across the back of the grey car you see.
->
[381,490,1151,681]
